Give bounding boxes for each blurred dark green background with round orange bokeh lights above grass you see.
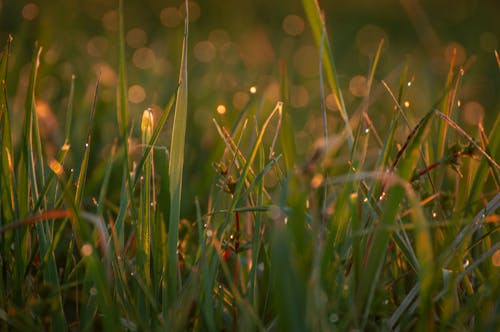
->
[0,0,500,211]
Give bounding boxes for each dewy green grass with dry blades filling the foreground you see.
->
[0,0,500,331]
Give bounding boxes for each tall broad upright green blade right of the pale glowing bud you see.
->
[164,1,189,306]
